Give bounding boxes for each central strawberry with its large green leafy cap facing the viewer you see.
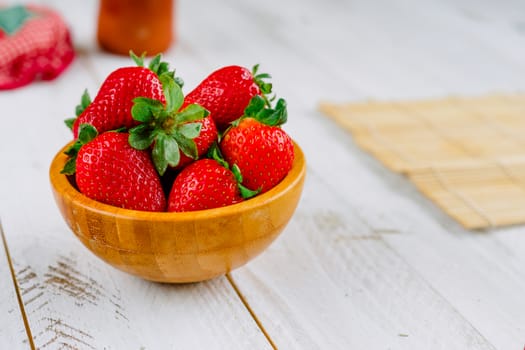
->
[129,76,213,175]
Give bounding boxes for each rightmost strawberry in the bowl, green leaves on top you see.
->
[220,96,294,192]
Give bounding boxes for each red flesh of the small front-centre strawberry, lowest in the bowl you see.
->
[168,159,243,212]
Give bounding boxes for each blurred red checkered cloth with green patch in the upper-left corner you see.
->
[0,5,75,90]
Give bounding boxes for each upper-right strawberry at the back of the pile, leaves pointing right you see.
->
[186,65,272,131]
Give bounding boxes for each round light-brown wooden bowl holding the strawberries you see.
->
[49,144,306,283]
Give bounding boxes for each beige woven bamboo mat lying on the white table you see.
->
[320,95,525,229]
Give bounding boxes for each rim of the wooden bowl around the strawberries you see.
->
[49,141,306,222]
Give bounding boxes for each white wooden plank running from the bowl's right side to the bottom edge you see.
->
[232,171,494,349]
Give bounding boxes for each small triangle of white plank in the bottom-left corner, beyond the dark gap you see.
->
[0,222,30,349]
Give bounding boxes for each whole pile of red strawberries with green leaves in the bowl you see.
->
[62,54,294,212]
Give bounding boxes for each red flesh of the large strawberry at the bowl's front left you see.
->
[65,132,166,211]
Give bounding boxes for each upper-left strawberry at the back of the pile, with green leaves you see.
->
[66,55,178,139]
